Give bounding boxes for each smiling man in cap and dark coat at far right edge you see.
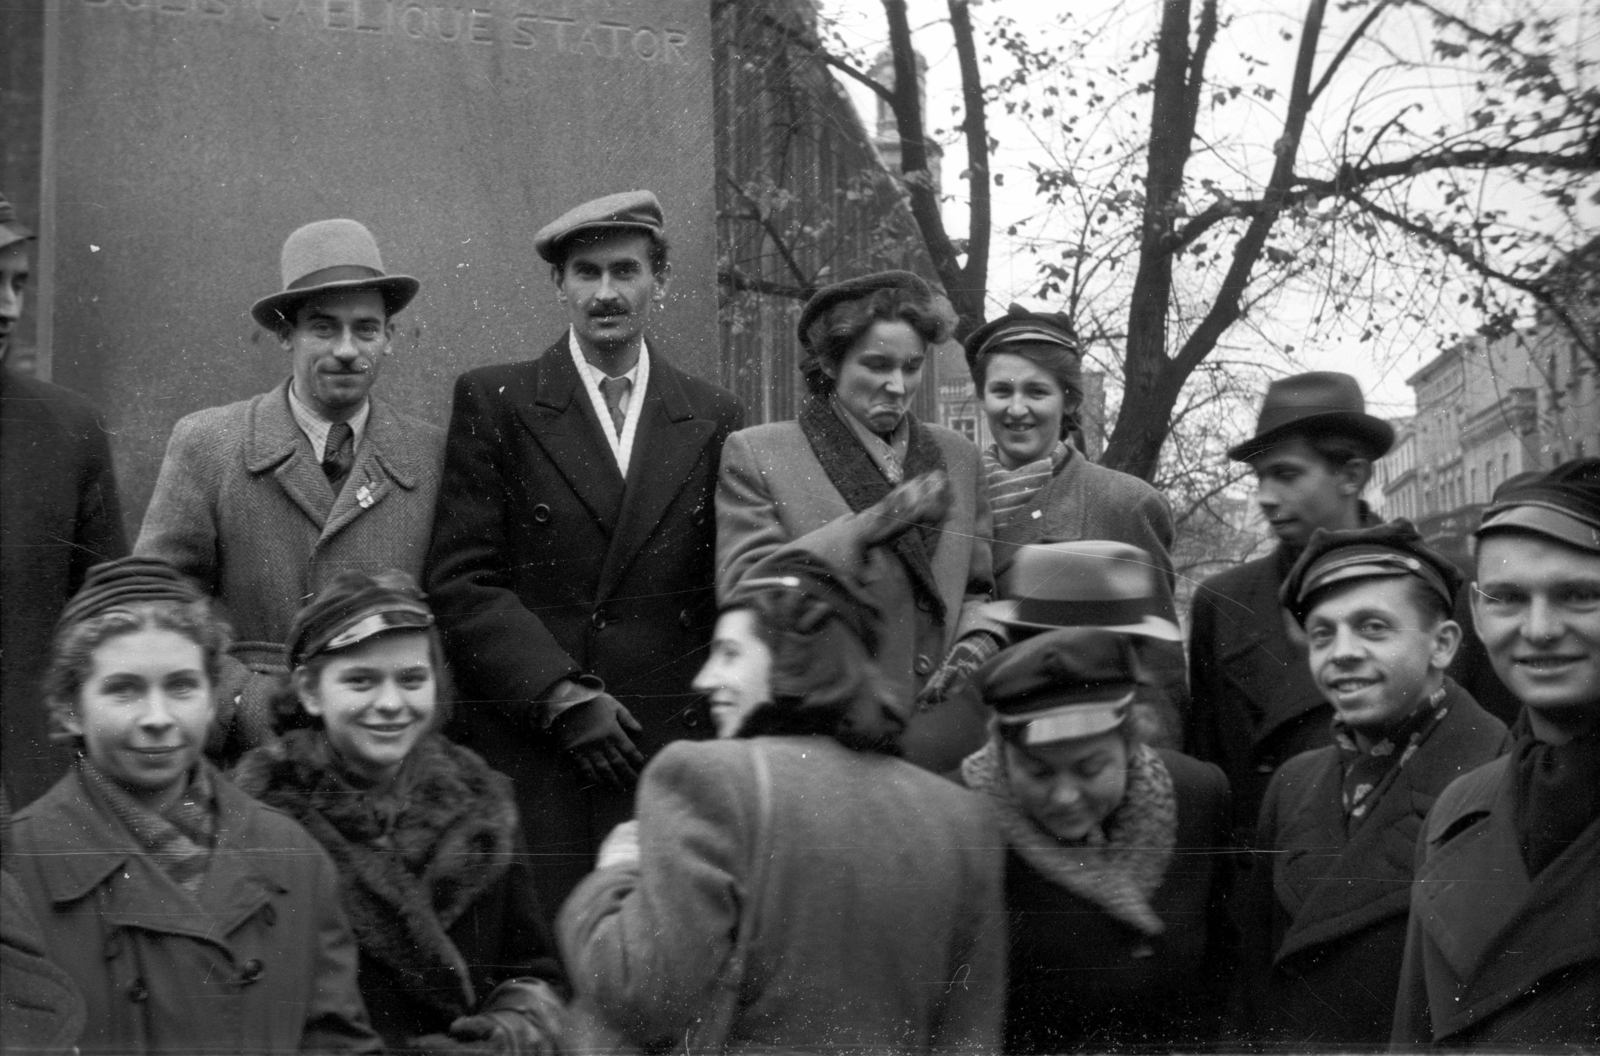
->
[1390,458,1600,1051]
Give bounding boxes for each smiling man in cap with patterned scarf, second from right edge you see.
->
[1235,520,1506,1050]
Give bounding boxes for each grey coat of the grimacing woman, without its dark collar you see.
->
[717,422,1005,771]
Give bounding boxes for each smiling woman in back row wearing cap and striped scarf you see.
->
[965,304,1189,747]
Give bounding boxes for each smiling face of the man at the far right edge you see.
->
[1472,533,1600,725]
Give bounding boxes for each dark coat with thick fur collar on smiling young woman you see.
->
[234,730,565,1048]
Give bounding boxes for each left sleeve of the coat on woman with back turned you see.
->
[557,741,755,1048]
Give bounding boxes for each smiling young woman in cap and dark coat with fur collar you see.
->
[234,571,565,1056]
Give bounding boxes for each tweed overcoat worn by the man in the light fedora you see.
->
[134,382,445,755]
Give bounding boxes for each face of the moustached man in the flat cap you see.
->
[555,232,667,354]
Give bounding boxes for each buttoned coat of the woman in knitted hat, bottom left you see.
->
[6,770,381,1056]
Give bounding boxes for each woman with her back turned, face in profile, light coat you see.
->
[558,496,1005,1053]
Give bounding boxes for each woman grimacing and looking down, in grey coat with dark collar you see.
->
[717,272,1003,770]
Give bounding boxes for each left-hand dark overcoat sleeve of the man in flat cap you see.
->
[426,373,582,714]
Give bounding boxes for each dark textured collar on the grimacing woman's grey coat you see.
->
[800,398,946,624]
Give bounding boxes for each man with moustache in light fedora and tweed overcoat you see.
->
[134,219,445,757]
